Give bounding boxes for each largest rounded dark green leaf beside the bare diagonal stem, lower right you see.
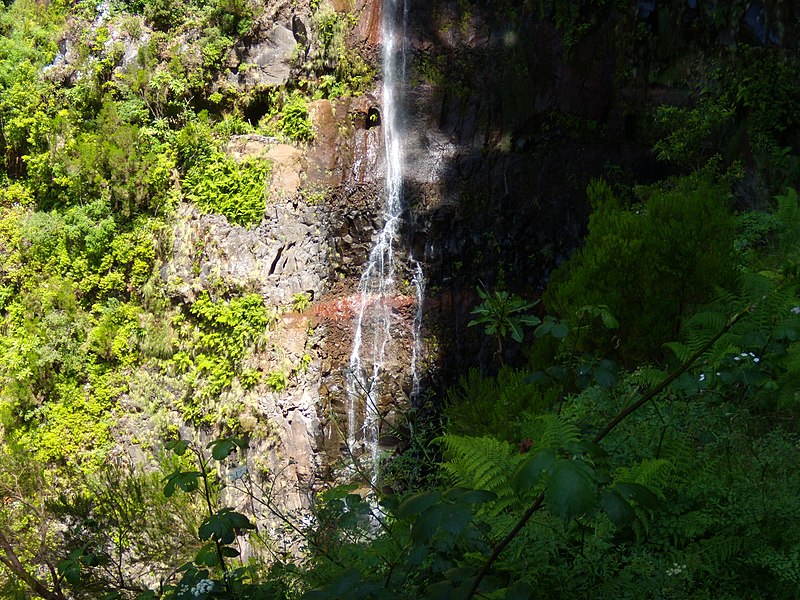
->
[544,459,597,519]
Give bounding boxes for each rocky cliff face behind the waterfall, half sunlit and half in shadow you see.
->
[114,0,793,506]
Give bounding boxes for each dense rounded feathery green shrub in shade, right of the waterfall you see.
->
[544,173,734,360]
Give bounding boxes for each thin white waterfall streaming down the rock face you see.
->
[347,0,412,484]
